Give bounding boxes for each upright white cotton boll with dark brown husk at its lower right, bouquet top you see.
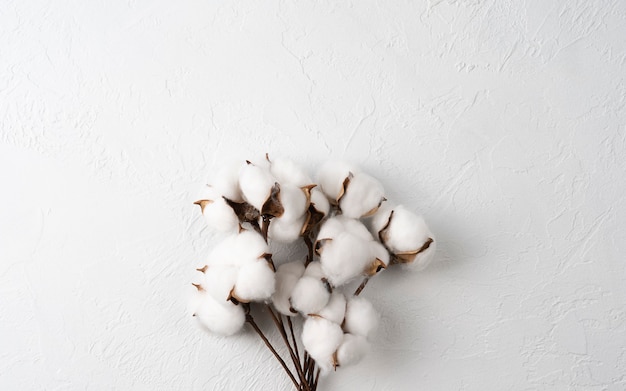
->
[239,163,282,216]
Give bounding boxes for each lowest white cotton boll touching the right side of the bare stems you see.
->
[302,316,343,369]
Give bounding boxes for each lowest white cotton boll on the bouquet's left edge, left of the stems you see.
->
[190,286,246,336]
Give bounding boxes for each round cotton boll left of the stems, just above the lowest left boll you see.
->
[232,259,276,302]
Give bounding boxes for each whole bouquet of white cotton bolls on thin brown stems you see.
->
[191,155,436,391]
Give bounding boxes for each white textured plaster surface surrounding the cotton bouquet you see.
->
[0,0,626,391]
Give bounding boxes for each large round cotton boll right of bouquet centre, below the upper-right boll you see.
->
[320,233,375,286]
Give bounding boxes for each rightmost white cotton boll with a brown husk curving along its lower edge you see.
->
[372,205,436,270]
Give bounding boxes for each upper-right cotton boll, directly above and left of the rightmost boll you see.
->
[339,173,385,218]
